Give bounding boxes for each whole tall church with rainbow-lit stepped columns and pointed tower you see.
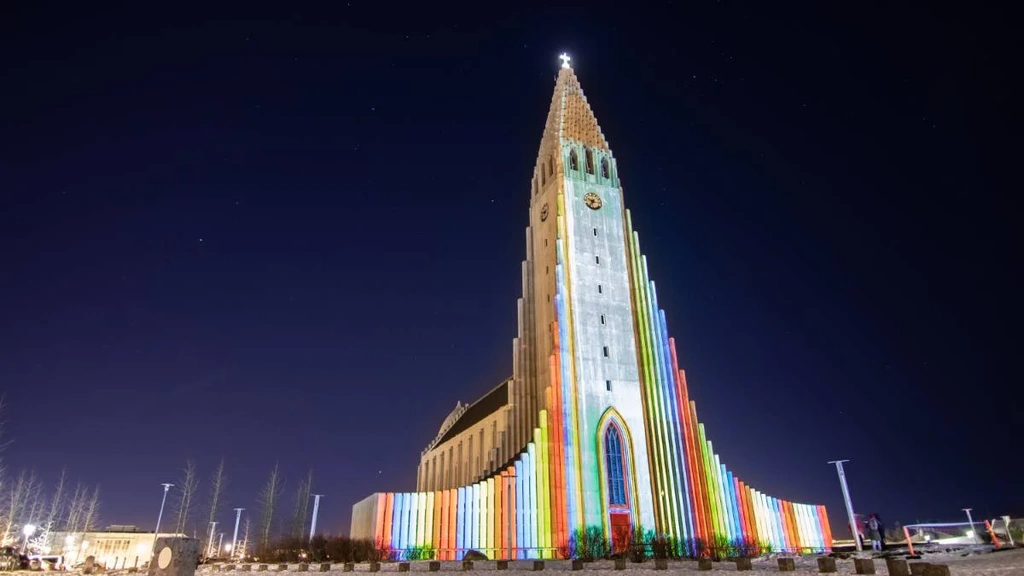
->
[351,54,831,560]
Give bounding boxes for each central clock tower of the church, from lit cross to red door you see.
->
[513,55,654,534]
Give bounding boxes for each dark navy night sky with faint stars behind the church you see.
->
[0,1,1011,533]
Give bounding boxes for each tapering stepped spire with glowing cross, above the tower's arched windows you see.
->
[537,53,610,175]
